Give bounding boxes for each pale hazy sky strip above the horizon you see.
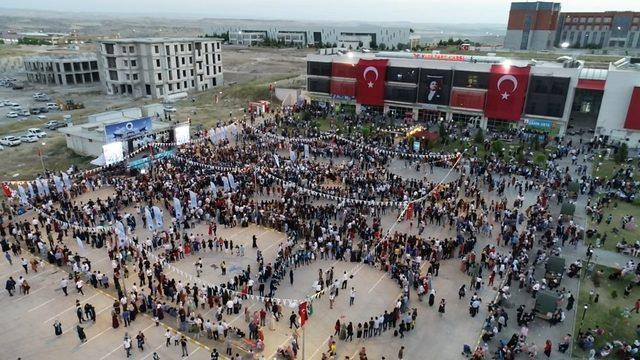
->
[7,0,640,23]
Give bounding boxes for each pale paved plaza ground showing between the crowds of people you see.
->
[0,132,636,360]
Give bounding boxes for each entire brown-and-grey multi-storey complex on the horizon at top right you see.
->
[504,1,640,53]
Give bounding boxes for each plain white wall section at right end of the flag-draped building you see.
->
[596,70,640,148]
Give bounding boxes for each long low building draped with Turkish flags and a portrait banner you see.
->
[307,52,640,147]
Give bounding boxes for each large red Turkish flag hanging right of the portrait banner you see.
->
[484,65,531,121]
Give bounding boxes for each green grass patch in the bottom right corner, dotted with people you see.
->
[573,265,640,359]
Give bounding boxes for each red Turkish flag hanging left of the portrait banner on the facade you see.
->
[356,59,389,106]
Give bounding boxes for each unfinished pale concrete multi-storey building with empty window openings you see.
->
[98,38,223,98]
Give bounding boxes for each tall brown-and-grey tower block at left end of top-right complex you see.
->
[504,1,560,50]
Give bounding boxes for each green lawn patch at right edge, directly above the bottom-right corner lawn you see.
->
[587,200,640,252]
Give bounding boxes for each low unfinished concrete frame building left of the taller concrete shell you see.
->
[23,53,100,85]
